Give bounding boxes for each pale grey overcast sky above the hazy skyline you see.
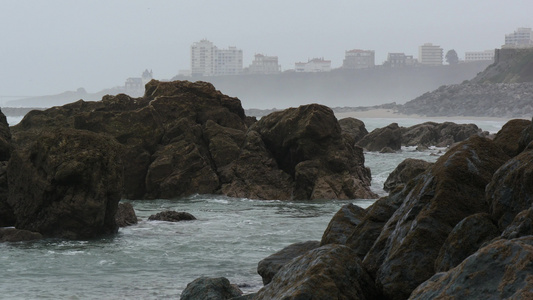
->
[0,0,533,101]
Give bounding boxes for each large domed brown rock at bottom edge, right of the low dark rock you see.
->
[254,244,378,300]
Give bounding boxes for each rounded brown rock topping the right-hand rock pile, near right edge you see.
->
[494,119,531,157]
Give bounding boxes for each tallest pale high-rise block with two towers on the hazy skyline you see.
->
[191,39,243,76]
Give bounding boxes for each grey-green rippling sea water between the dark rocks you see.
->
[0,119,503,299]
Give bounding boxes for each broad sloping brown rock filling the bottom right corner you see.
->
[409,236,533,300]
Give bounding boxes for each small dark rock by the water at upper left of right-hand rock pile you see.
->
[383,158,433,192]
